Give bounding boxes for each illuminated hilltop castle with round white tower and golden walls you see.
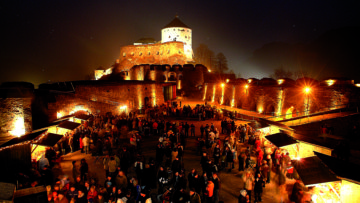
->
[95,16,194,82]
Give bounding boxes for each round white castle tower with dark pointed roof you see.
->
[161,16,193,61]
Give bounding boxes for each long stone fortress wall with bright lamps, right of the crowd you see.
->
[203,79,360,118]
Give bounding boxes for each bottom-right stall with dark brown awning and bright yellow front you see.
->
[291,156,341,203]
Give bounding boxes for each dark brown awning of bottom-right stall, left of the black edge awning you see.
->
[291,156,339,186]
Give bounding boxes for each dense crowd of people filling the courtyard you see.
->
[14,102,300,203]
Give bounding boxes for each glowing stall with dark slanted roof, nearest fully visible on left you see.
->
[31,133,63,162]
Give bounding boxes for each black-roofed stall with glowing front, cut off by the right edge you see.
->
[315,152,360,203]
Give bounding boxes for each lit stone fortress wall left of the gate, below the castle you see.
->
[48,81,173,120]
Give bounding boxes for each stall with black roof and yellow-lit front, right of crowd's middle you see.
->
[264,133,299,159]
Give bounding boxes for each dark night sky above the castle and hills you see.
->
[0,0,360,85]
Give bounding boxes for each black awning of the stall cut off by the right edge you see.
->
[314,152,360,183]
